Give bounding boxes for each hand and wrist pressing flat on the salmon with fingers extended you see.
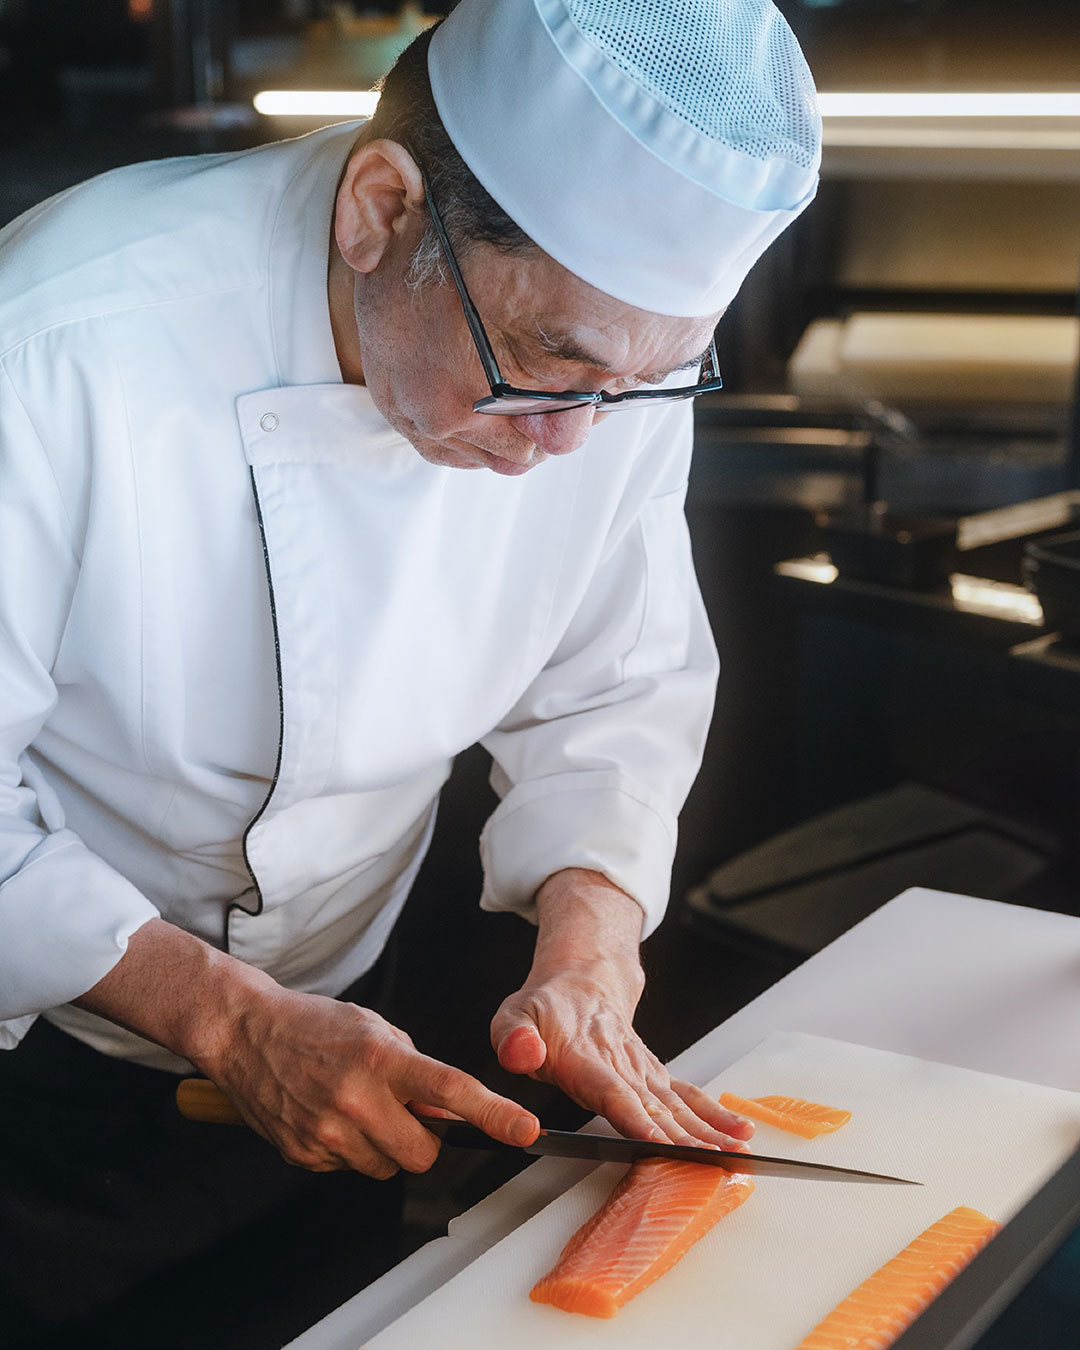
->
[491,869,753,1149]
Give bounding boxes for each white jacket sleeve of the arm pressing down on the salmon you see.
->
[481,424,718,933]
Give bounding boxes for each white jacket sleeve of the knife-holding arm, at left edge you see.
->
[0,362,158,1049]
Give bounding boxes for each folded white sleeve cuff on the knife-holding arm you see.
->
[0,830,159,1019]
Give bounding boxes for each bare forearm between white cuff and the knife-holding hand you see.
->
[74,918,277,1068]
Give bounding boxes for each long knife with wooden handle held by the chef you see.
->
[177,1079,922,1185]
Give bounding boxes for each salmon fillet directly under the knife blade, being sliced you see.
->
[529,1158,753,1318]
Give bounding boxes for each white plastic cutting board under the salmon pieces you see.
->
[367,1031,1080,1350]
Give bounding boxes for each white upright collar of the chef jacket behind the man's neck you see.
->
[267,122,362,385]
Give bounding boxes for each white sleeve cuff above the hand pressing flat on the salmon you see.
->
[481,772,676,937]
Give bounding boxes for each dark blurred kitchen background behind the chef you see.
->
[0,0,1080,1263]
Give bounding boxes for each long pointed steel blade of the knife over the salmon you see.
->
[416,1114,922,1185]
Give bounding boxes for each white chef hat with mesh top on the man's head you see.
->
[428,0,821,316]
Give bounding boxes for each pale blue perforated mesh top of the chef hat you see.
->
[564,0,818,169]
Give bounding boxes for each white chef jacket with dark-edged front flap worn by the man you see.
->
[0,124,717,1069]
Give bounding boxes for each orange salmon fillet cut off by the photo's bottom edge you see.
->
[797,1206,1000,1350]
